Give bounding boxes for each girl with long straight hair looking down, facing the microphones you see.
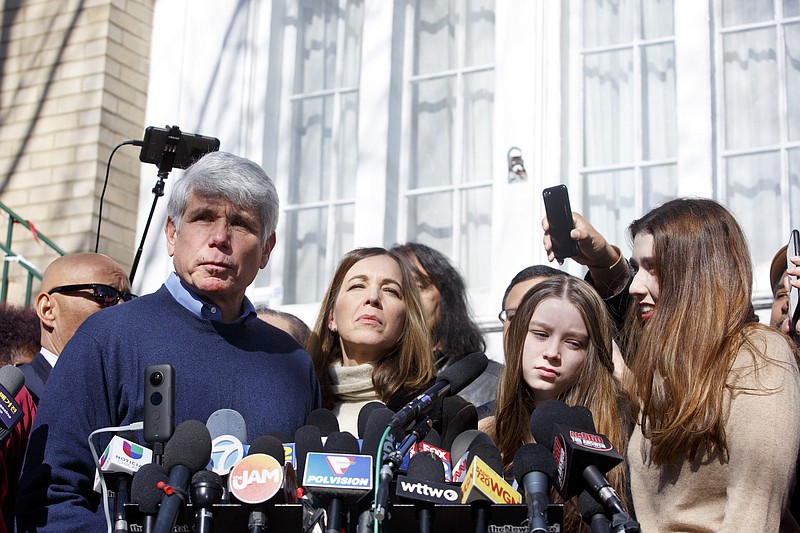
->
[479,276,627,531]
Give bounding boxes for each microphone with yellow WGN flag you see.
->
[461,433,522,532]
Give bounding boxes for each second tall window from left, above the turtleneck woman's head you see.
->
[400,0,495,288]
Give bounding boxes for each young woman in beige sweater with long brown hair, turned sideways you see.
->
[626,199,800,532]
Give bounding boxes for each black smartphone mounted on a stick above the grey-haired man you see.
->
[139,126,219,170]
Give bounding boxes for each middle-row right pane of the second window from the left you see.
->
[464,70,494,183]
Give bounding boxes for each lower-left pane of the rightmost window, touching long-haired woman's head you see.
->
[725,152,785,262]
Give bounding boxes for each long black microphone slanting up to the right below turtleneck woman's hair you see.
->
[389,352,489,428]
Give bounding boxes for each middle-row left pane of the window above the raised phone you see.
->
[583,50,636,166]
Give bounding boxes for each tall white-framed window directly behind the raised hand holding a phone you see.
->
[573,0,678,249]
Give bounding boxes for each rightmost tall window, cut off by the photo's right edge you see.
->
[715,0,800,278]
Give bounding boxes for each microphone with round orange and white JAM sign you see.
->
[228,436,284,533]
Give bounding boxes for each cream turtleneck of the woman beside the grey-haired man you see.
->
[328,361,380,438]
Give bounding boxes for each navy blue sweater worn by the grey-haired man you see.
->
[17,287,320,532]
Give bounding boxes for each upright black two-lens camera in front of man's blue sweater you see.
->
[143,364,175,444]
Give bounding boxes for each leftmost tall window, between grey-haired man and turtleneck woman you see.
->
[283,0,364,304]
